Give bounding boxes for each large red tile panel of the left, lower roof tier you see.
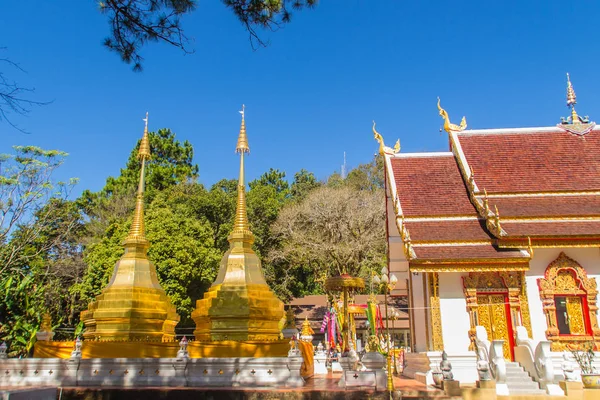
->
[391,154,477,216]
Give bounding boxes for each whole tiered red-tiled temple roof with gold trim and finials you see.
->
[384,75,600,271]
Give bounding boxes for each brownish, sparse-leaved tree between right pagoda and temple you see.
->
[269,186,385,295]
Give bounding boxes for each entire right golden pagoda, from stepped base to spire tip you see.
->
[192,108,284,341]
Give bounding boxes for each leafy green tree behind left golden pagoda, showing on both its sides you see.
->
[75,183,222,326]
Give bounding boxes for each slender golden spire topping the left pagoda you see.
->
[124,113,151,247]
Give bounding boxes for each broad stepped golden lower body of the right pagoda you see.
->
[192,284,284,341]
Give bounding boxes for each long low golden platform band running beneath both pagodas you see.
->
[33,340,290,359]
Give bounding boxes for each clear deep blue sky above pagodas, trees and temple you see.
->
[0,0,600,194]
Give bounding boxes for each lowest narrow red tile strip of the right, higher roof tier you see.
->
[500,219,600,237]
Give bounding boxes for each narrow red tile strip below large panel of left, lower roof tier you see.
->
[405,219,490,242]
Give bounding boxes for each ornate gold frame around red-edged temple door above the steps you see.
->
[463,271,531,351]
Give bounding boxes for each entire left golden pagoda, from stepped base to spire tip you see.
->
[81,113,179,341]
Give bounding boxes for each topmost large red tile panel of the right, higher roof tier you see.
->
[458,131,600,193]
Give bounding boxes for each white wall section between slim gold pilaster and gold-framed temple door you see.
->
[439,272,471,355]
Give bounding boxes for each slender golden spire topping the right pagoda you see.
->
[229,105,254,243]
